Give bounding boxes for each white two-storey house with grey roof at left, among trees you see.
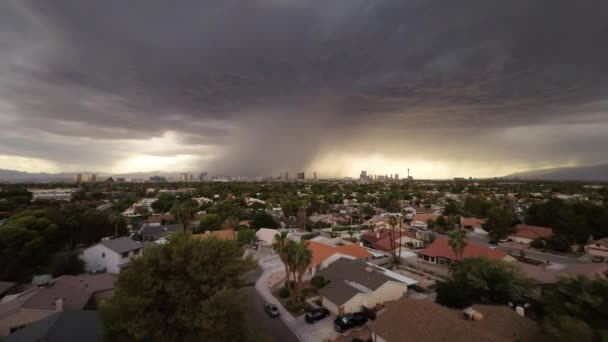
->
[82,236,144,273]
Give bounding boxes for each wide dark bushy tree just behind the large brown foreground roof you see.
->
[437,258,534,307]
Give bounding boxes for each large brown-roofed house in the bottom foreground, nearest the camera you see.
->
[369,298,542,342]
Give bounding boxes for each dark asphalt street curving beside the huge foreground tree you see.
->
[244,267,298,342]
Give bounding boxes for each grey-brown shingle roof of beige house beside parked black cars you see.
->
[319,258,395,306]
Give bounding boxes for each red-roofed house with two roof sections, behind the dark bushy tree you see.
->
[418,237,515,264]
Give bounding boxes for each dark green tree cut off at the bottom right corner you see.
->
[540,276,608,341]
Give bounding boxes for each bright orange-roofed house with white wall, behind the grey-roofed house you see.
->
[308,241,372,277]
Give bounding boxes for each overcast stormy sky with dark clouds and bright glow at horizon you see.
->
[0,0,608,178]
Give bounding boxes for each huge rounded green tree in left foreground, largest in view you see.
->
[100,233,255,342]
